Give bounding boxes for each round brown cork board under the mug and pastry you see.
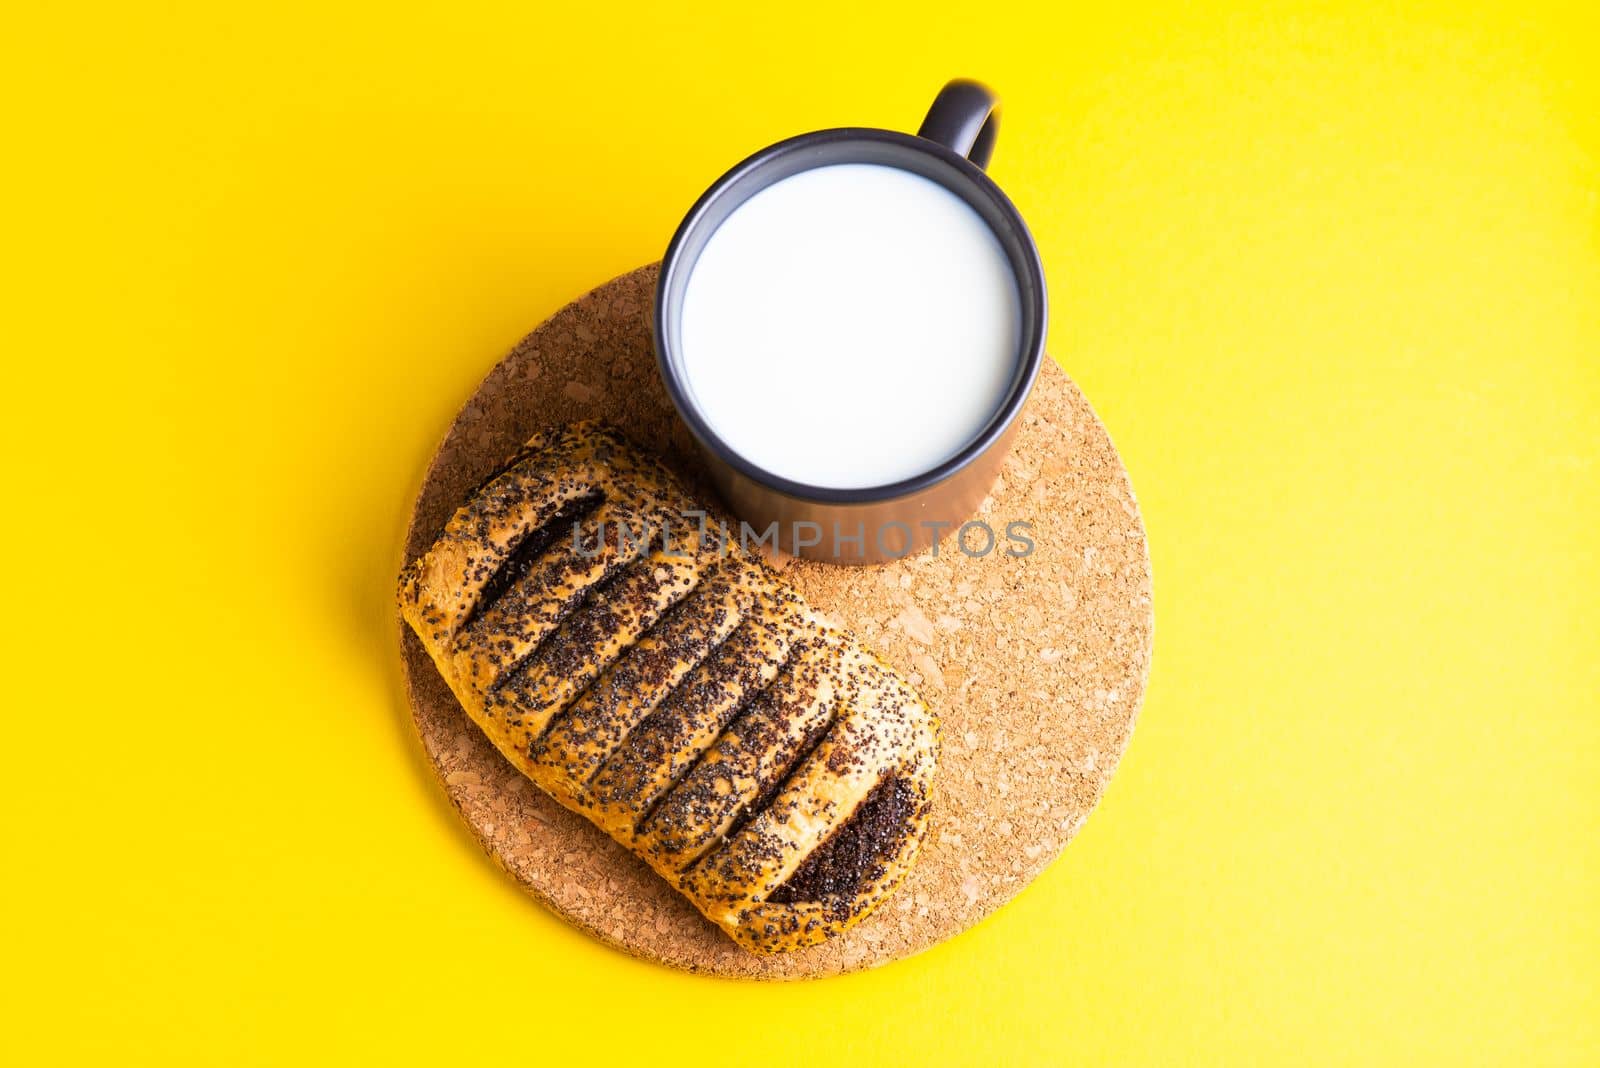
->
[400,265,1154,978]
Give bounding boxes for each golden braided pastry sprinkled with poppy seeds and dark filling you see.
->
[400,422,938,953]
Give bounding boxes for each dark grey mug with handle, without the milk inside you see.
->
[654,80,1046,564]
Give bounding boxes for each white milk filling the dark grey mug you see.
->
[682,163,1022,489]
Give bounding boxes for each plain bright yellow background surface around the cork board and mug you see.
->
[0,2,1600,1065]
